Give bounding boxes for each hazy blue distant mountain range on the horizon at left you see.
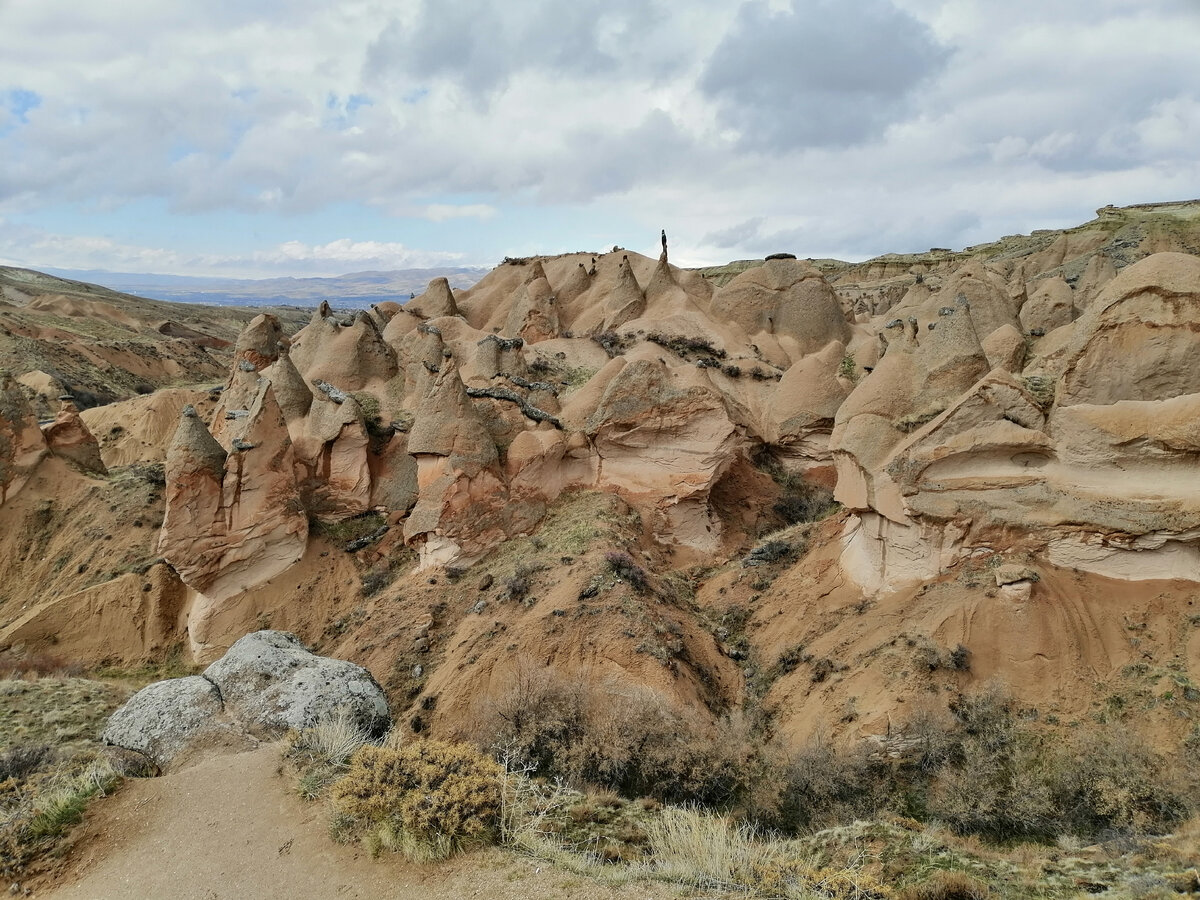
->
[42,266,488,308]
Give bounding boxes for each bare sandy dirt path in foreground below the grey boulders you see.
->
[36,746,676,900]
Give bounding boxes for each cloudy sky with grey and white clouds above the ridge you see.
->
[0,0,1200,277]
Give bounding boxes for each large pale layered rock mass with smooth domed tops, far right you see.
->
[832,253,1200,590]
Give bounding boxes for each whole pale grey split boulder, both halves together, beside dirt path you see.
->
[103,631,391,768]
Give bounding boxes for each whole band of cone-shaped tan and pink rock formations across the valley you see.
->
[119,234,1200,662]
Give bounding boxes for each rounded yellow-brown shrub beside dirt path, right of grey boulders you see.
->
[332,740,503,860]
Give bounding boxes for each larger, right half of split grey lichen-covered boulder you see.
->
[204,631,391,737]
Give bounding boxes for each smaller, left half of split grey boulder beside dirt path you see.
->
[103,676,230,767]
